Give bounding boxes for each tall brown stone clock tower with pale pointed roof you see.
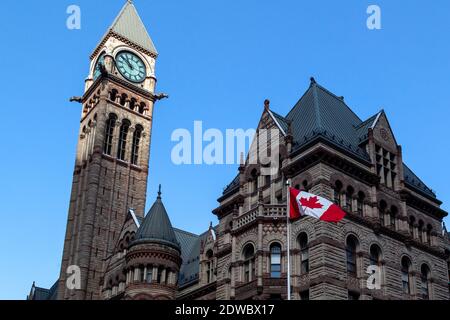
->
[58,0,163,300]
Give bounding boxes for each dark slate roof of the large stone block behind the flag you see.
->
[223,78,436,198]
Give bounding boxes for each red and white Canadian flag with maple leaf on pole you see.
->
[289,188,345,222]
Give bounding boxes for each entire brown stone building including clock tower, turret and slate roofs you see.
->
[29,1,450,300]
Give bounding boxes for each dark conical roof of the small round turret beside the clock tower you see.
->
[134,186,180,250]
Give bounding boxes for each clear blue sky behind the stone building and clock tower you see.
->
[0,0,450,299]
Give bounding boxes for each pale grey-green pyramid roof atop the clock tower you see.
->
[109,1,158,54]
